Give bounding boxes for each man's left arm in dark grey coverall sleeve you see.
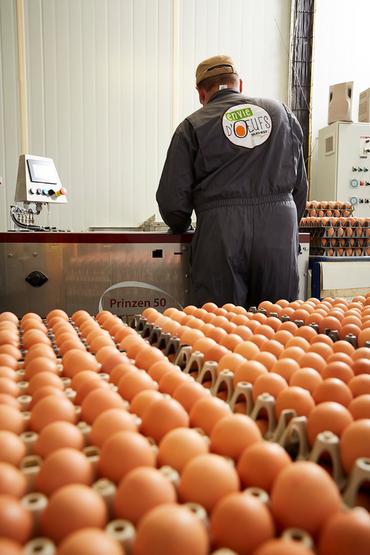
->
[156,120,197,233]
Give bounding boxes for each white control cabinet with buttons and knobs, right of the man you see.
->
[311,122,370,217]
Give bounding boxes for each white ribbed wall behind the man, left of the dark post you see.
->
[0,0,290,231]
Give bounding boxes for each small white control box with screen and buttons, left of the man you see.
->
[15,154,67,204]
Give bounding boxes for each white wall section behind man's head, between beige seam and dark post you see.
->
[179,0,290,126]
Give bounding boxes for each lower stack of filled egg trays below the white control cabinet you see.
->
[300,217,370,257]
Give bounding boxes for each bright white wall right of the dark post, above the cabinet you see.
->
[311,0,370,200]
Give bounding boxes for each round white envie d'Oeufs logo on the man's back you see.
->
[222,104,272,148]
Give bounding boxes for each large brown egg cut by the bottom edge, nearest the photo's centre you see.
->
[134,504,209,555]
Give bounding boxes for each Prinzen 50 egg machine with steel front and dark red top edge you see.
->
[0,231,309,316]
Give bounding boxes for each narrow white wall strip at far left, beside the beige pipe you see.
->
[0,0,20,231]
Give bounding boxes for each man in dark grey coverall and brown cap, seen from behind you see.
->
[157,56,307,308]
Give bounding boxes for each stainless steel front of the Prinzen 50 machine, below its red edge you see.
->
[0,242,189,316]
